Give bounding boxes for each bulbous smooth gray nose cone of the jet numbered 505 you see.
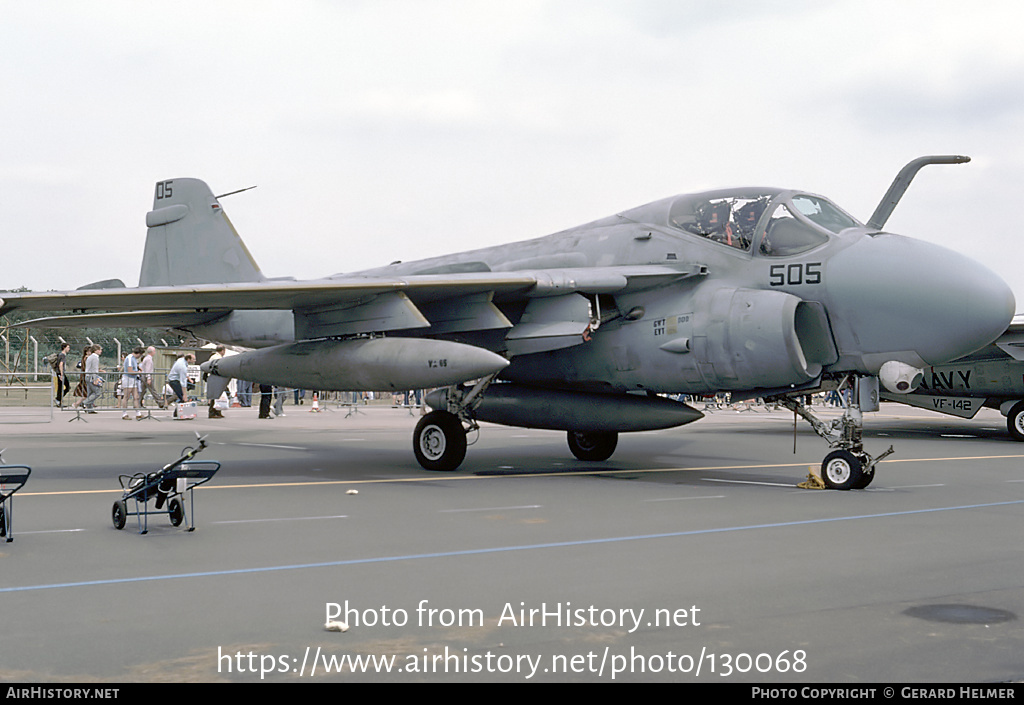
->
[826,234,1015,372]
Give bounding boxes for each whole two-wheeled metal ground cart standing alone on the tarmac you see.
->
[111,433,220,534]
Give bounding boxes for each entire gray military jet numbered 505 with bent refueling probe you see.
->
[0,157,1014,489]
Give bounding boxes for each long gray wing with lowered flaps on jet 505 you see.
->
[0,264,707,351]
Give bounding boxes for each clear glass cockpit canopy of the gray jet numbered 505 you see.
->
[668,189,860,257]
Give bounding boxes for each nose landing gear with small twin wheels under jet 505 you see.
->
[778,383,894,490]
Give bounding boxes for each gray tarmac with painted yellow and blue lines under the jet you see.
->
[0,403,1024,683]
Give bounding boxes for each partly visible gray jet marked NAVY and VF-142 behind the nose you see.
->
[882,316,1024,441]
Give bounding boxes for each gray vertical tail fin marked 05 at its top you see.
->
[138,178,265,287]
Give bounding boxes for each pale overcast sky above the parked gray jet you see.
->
[0,0,1024,310]
